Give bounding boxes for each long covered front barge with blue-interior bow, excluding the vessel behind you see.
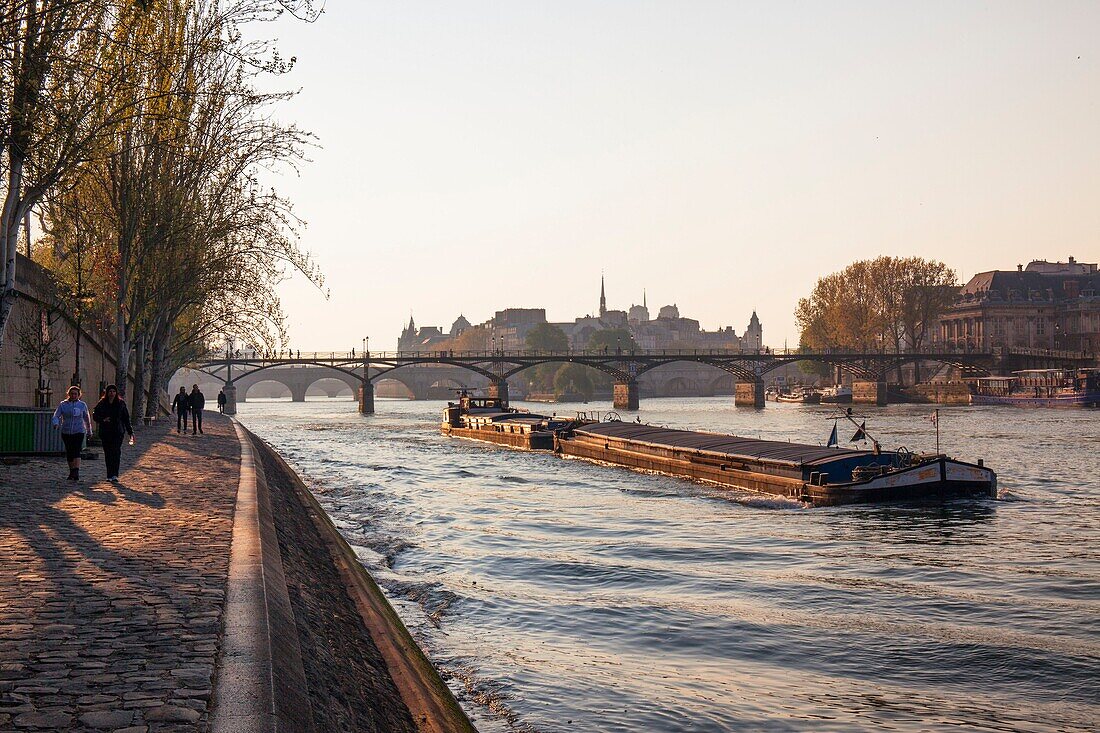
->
[554,423,997,506]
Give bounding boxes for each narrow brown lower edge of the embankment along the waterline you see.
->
[245,422,476,733]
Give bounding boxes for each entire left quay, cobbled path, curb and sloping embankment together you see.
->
[0,413,473,733]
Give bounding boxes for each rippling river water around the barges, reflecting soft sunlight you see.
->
[240,397,1100,733]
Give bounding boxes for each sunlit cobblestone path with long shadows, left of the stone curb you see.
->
[0,413,240,733]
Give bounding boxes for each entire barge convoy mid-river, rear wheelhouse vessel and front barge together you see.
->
[440,391,997,506]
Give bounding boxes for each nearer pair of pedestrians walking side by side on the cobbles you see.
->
[54,384,134,483]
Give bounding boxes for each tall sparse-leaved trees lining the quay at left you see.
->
[0,0,322,415]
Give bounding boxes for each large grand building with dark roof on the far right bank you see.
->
[936,258,1100,353]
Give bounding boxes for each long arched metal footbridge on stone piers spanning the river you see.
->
[189,349,1095,414]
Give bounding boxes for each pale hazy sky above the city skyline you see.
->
[264,0,1100,350]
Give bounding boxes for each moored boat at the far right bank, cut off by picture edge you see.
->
[970,369,1100,407]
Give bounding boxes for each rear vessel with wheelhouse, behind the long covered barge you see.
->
[440,391,575,450]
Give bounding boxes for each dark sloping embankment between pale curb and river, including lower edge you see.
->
[229,428,474,733]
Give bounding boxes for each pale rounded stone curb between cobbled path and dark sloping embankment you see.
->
[210,419,314,733]
